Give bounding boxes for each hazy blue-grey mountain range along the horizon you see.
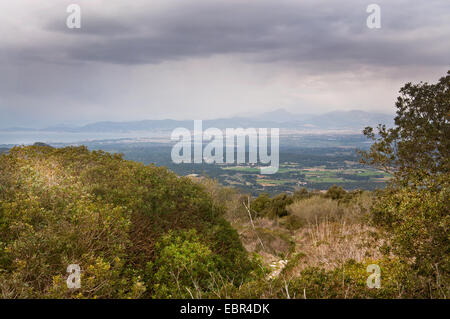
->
[0,109,394,133]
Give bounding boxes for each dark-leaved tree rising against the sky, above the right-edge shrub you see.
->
[361,71,450,182]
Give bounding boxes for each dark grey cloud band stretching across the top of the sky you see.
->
[22,0,449,67]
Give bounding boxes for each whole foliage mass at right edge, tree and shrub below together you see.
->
[362,71,450,297]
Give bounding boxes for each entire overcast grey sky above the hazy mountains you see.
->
[0,0,450,127]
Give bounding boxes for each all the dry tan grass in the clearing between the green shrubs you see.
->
[240,194,386,275]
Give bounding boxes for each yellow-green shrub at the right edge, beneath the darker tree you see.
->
[373,177,450,297]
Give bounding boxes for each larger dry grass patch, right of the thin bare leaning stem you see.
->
[288,194,386,272]
